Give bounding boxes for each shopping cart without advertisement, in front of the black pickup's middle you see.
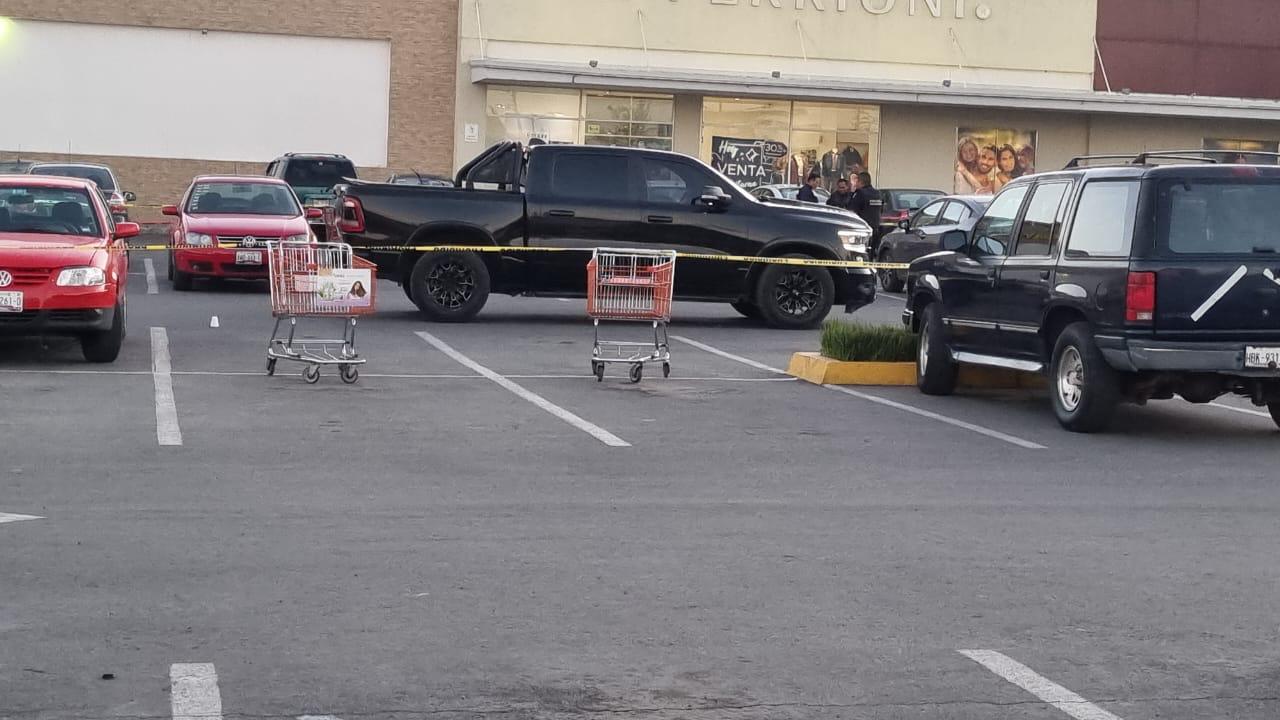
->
[586,247,676,383]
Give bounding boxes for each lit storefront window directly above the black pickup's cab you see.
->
[486,87,675,150]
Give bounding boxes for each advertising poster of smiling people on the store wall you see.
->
[954,127,1036,195]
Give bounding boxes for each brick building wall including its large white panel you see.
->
[0,0,458,220]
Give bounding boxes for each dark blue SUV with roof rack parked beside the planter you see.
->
[904,150,1280,432]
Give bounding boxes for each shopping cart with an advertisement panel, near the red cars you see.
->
[266,242,378,383]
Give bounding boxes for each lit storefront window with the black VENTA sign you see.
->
[701,97,879,188]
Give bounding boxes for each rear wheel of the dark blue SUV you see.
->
[1048,323,1120,433]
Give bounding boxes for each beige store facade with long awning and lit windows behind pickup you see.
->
[454,0,1280,192]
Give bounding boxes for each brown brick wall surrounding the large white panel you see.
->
[0,0,458,220]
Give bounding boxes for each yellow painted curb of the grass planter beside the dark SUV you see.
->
[787,352,1044,389]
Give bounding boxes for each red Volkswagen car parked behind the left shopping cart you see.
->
[163,176,324,291]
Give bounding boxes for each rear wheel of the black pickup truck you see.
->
[410,252,489,323]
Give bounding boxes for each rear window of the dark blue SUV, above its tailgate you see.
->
[1156,178,1280,255]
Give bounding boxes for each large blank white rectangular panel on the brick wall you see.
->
[0,20,390,165]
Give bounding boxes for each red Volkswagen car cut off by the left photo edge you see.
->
[0,176,141,363]
